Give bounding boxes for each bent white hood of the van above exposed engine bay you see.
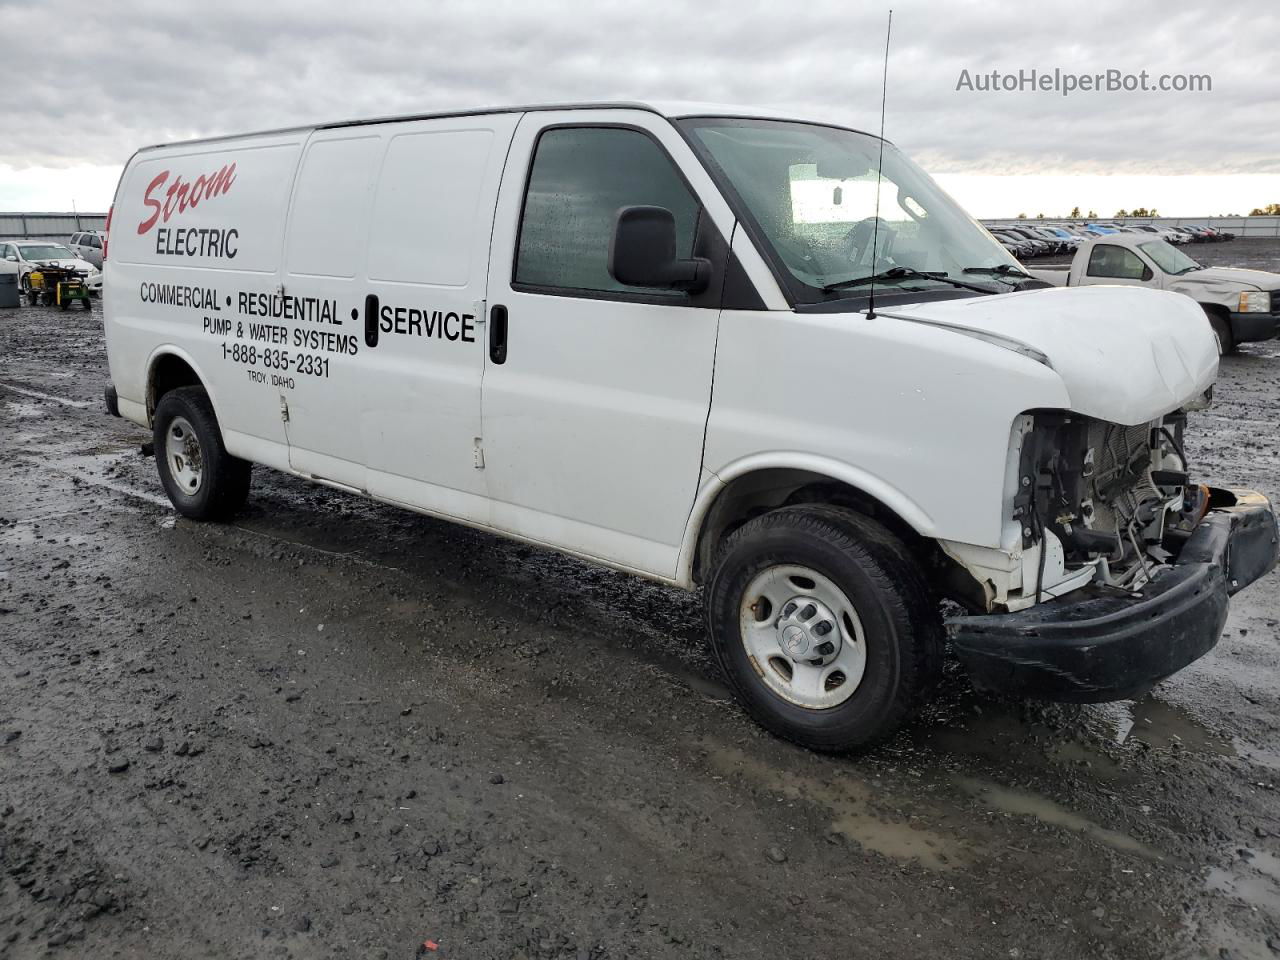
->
[877,287,1217,426]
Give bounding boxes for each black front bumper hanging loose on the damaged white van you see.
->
[947,489,1280,703]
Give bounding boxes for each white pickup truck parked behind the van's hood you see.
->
[1028,233,1280,355]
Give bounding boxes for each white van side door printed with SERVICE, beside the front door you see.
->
[362,114,520,525]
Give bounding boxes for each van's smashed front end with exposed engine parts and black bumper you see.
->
[945,411,1277,701]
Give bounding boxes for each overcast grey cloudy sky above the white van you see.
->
[0,0,1280,216]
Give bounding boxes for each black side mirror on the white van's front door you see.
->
[609,206,712,293]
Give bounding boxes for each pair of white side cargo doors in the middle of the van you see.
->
[271,114,517,506]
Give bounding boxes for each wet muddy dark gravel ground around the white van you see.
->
[0,242,1280,960]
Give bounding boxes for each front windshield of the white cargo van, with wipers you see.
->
[678,116,1025,302]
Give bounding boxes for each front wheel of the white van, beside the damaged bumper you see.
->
[707,504,943,753]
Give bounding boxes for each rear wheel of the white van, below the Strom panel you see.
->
[152,387,251,520]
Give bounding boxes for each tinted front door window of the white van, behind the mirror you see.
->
[515,127,699,300]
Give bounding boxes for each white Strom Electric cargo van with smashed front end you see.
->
[104,104,1276,750]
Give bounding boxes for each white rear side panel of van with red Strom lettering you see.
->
[102,132,306,466]
